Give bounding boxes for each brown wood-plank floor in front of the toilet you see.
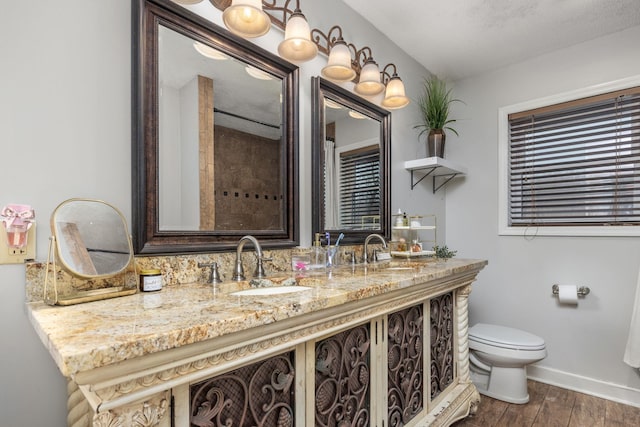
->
[453,381,640,427]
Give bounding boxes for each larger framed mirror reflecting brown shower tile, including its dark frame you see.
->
[132,0,298,254]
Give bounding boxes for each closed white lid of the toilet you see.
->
[469,323,544,351]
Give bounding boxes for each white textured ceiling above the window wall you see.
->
[343,0,640,80]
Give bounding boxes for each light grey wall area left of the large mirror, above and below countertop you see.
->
[0,0,131,426]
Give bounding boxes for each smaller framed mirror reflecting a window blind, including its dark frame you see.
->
[312,77,391,243]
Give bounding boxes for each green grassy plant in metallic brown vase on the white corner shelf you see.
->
[414,76,462,157]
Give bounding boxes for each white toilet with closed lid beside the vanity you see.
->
[469,323,547,403]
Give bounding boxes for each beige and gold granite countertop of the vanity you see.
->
[27,258,486,377]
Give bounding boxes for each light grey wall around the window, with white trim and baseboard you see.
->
[446,27,640,406]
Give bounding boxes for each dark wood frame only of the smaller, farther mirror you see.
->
[311,77,391,244]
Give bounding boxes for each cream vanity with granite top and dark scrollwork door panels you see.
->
[27,258,486,427]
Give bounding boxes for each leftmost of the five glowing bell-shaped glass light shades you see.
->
[222,0,271,38]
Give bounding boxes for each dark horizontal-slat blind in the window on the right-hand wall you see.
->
[509,87,640,226]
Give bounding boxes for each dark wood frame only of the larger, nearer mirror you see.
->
[132,0,299,255]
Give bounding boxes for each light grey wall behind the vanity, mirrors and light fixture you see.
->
[0,0,436,427]
